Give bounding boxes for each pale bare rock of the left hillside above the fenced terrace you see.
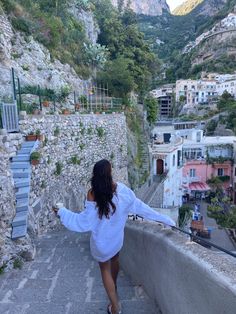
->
[0,11,98,97]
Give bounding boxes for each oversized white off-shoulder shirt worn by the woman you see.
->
[58,183,175,262]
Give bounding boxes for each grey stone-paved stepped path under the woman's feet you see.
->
[0,229,161,314]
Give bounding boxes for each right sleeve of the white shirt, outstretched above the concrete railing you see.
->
[128,189,175,226]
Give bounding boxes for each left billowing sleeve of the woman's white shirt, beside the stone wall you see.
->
[58,202,97,232]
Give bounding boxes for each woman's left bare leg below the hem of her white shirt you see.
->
[99,261,119,314]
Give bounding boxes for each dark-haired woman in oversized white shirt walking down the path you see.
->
[54,159,175,314]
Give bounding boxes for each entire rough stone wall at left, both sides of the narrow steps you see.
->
[0,114,128,270]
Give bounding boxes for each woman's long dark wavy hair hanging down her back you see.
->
[91,159,116,219]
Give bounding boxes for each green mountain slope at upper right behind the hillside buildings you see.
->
[138,0,236,83]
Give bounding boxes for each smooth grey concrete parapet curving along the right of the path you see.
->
[121,221,236,314]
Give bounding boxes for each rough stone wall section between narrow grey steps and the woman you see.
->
[20,114,128,233]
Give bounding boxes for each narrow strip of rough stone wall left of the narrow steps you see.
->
[0,134,34,269]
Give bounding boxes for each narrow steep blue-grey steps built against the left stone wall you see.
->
[11,141,38,240]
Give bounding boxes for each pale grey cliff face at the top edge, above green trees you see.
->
[112,0,170,16]
